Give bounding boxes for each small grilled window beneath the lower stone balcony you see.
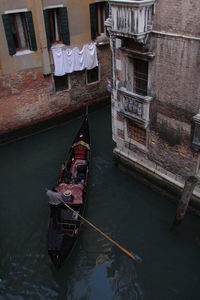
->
[127,120,146,146]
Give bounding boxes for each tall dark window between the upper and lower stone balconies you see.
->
[126,57,148,96]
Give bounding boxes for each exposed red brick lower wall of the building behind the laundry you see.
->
[0,46,110,134]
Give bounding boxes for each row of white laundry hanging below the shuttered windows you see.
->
[52,43,98,76]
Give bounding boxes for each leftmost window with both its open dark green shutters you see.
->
[2,11,37,55]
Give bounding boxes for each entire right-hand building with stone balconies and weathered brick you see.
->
[106,0,200,197]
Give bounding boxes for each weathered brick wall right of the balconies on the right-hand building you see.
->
[148,0,200,176]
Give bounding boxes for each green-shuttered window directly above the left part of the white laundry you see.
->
[43,7,70,48]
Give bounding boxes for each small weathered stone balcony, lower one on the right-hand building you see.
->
[118,88,152,128]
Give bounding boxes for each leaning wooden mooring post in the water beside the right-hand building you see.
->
[171,176,198,230]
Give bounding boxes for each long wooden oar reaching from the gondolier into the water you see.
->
[62,201,138,261]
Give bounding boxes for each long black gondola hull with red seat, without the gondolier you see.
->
[47,116,90,268]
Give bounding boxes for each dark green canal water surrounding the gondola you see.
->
[0,106,200,300]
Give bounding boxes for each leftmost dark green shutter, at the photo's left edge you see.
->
[2,15,16,55]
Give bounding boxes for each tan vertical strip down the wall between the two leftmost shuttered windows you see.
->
[34,0,51,75]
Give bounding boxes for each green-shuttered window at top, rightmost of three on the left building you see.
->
[90,1,109,40]
